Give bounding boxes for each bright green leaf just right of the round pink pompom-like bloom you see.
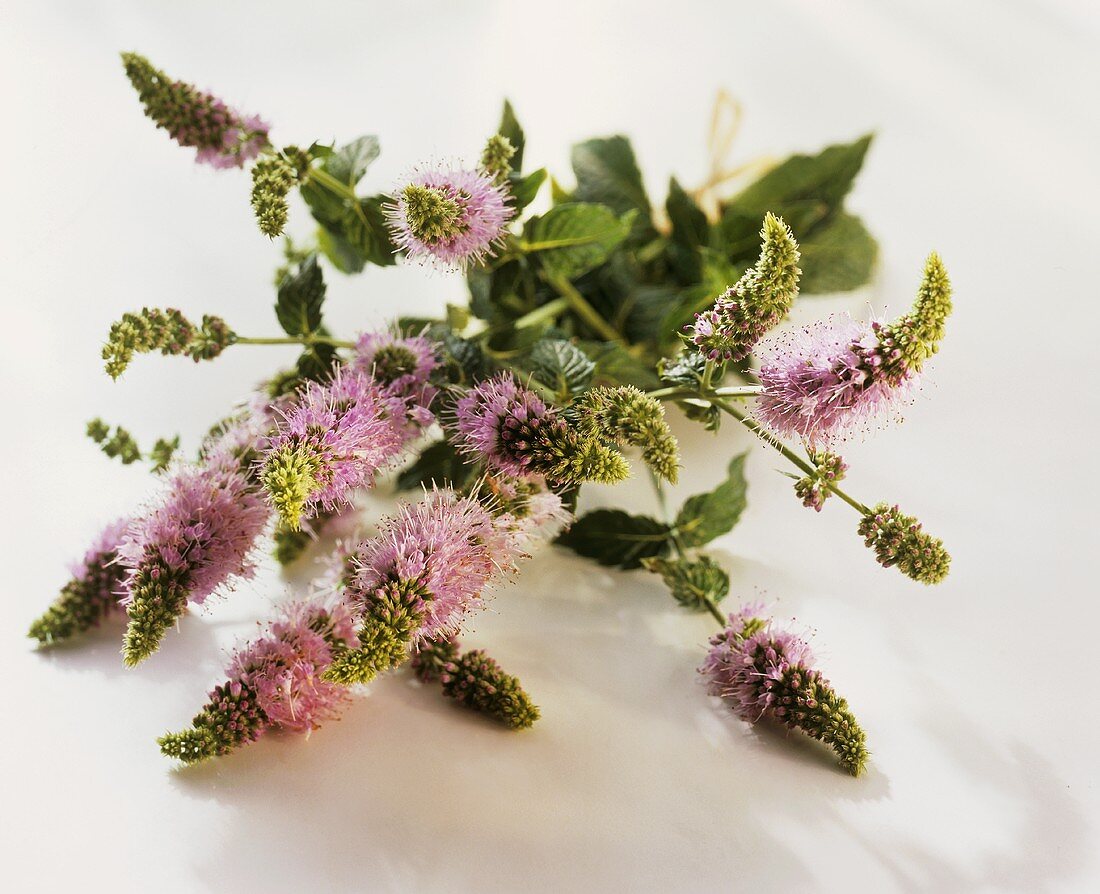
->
[525,202,634,279]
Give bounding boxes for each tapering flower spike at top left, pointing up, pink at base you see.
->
[122,53,268,168]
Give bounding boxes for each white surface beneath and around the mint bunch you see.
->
[0,0,1100,892]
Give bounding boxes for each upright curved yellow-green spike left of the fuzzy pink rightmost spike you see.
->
[684,212,802,361]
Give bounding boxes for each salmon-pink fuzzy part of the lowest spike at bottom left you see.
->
[229,603,359,732]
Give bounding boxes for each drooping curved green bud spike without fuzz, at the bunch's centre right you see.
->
[568,385,680,484]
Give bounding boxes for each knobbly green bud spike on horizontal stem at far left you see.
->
[102,308,237,378]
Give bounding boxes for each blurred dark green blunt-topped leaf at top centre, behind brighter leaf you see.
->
[572,136,655,235]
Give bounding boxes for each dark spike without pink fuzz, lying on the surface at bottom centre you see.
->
[413,637,539,729]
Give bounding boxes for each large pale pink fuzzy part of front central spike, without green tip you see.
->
[348,490,523,640]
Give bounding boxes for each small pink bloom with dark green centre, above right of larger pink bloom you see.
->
[351,330,440,429]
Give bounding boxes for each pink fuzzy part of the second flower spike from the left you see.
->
[119,453,268,603]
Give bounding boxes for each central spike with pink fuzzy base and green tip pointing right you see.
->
[454,373,629,484]
